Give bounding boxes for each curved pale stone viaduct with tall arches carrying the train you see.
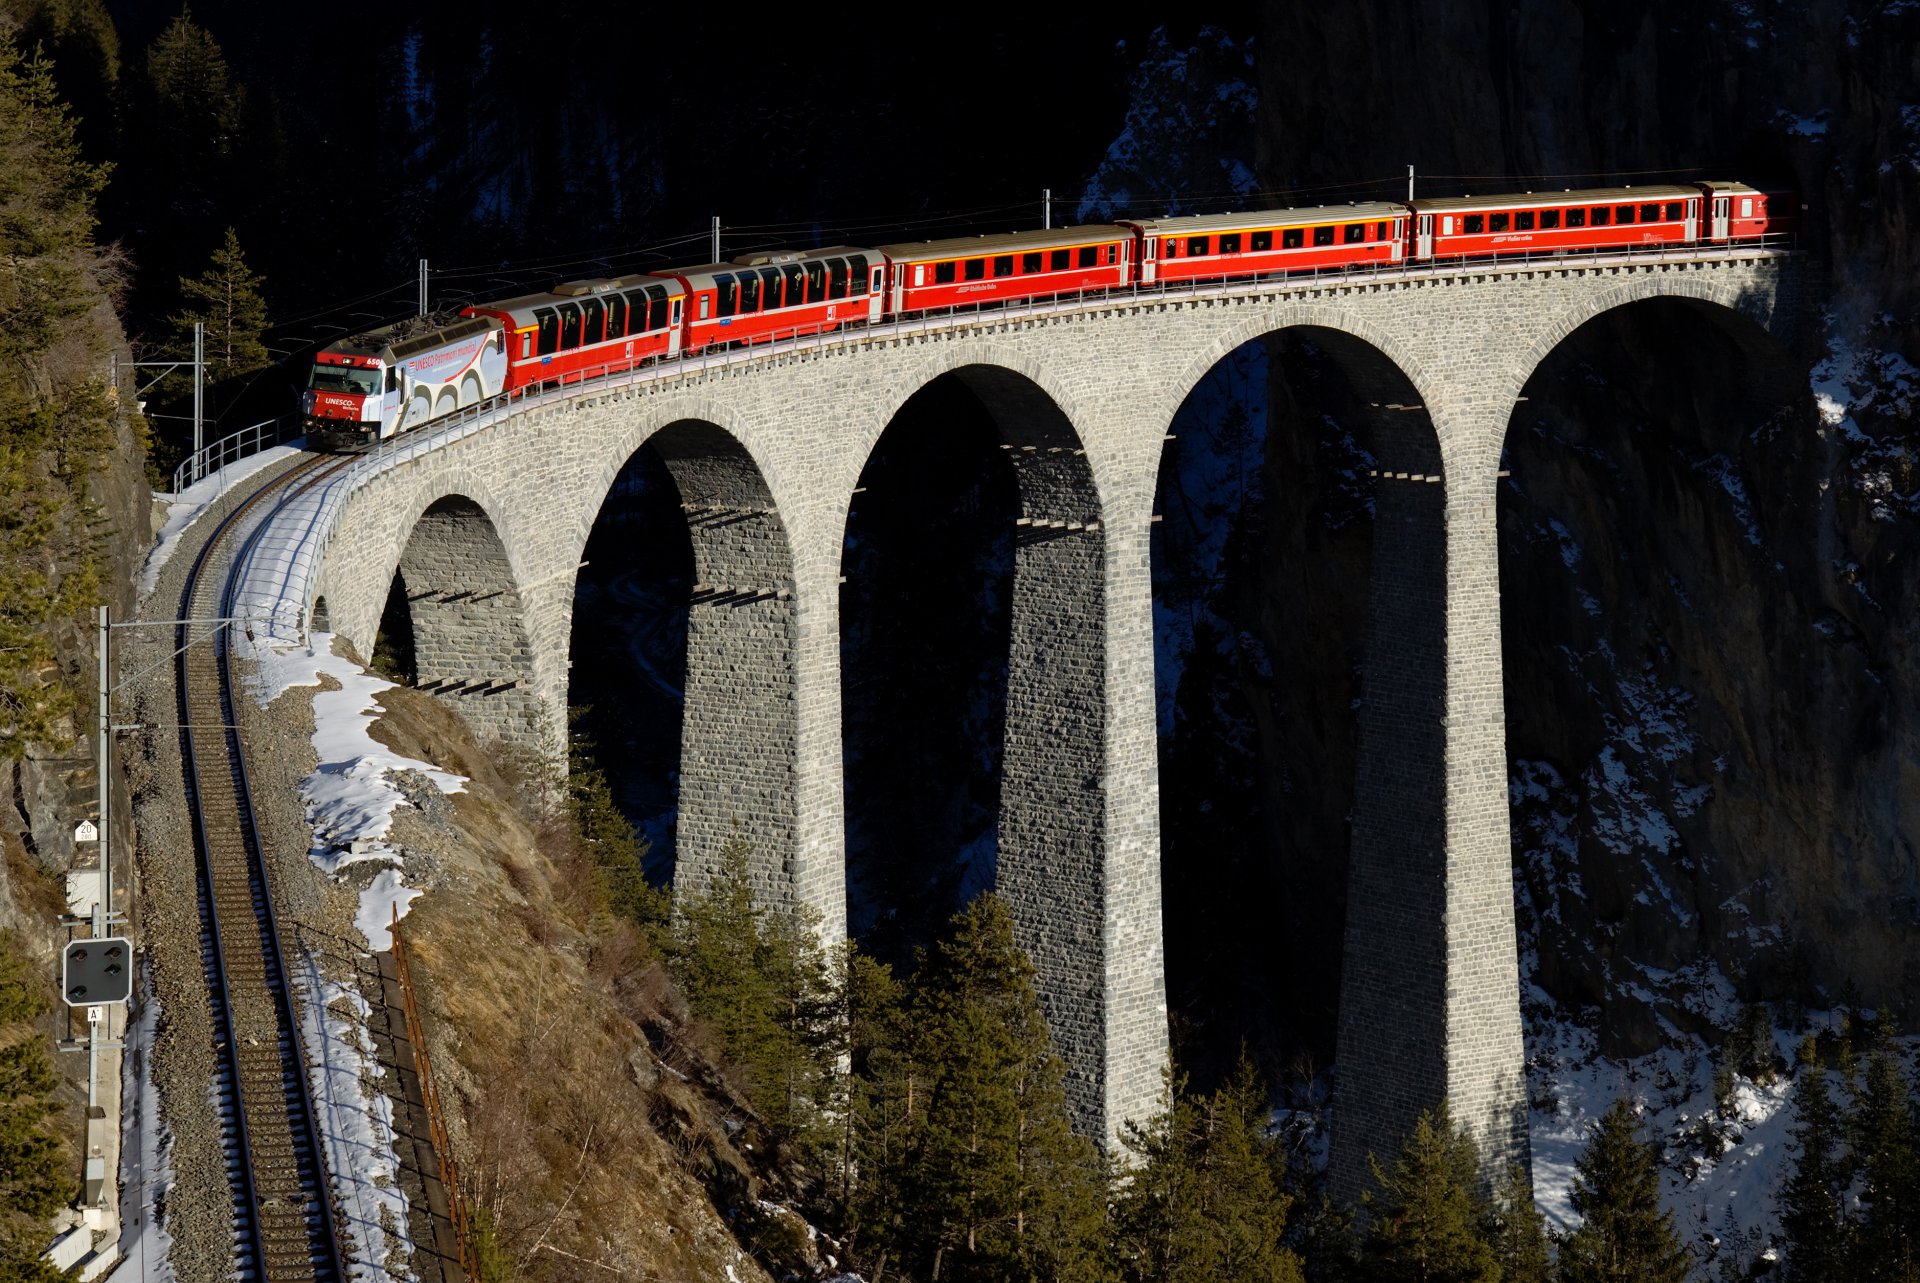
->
[242,250,1805,1189]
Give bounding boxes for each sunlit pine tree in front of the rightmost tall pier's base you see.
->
[1361,1102,1500,1283]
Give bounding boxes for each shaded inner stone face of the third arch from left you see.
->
[849,355,1113,1137]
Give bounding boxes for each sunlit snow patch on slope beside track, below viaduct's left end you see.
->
[242,632,467,951]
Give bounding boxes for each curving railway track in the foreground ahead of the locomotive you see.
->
[175,457,348,1283]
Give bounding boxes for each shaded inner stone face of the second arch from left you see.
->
[574,417,801,905]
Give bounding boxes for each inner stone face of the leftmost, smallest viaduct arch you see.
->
[394,492,543,743]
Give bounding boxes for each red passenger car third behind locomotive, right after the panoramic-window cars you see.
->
[879,223,1133,315]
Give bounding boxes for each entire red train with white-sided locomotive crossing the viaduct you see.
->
[301,182,1797,444]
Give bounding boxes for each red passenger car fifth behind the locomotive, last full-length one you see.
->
[1413,186,1701,259]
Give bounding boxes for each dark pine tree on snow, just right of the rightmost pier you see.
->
[1559,1099,1693,1283]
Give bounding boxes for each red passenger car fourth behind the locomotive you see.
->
[1123,204,1407,282]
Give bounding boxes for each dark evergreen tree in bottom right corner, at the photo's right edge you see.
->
[1849,1012,1920,1283]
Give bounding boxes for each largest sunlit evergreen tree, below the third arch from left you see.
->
[862,895,1112,1283]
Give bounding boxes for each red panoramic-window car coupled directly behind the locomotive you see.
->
[461,277,685,390]
